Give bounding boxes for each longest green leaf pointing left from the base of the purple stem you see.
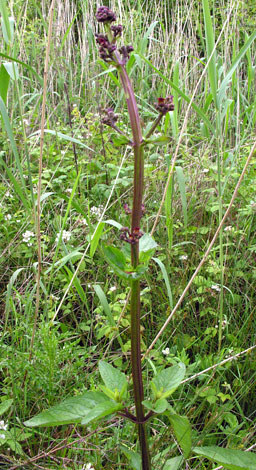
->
[24,392,109,427]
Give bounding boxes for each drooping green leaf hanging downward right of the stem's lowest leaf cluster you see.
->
[168,413,192,458]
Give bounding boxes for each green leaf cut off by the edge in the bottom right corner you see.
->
[193,446,256,470]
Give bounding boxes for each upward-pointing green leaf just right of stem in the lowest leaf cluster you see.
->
[151,362,186,398]
